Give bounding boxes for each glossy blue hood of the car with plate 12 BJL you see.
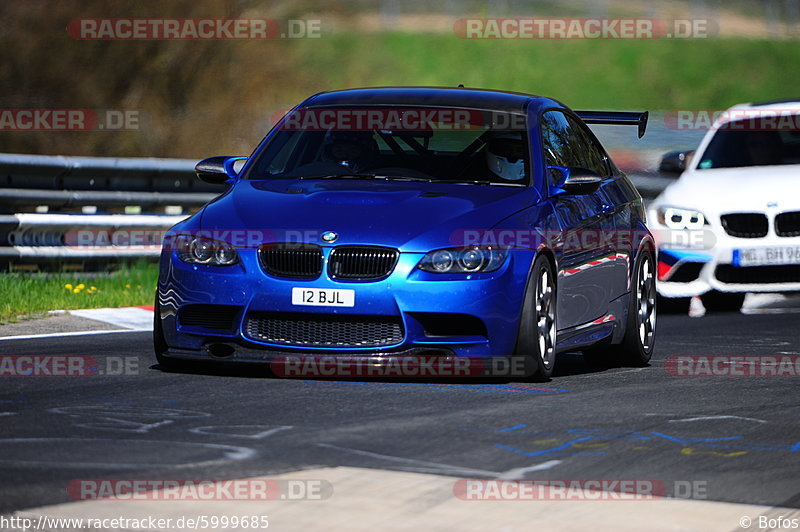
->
[201,180,538,252]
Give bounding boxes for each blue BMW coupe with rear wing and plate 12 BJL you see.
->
[154,87,656,380]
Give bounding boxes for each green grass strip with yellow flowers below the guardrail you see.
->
[0,262,158,323]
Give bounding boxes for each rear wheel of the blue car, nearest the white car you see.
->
[584,249,658,367]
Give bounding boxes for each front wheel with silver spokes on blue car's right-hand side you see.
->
[514,255,557,381]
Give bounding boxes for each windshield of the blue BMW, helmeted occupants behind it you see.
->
[245,107,530,186]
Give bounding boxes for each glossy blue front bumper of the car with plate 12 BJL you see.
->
[158,249,533,361]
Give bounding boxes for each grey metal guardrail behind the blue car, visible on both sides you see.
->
[0,154,673,267]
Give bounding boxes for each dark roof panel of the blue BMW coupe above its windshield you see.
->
[302,87,556,113]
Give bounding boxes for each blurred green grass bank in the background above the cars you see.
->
[288,33,800,109]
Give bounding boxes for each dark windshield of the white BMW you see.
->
[697,116,800,170]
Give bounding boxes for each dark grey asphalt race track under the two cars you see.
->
[0,308,800,513]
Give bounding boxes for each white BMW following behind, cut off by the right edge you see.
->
[648,100,800,312]
